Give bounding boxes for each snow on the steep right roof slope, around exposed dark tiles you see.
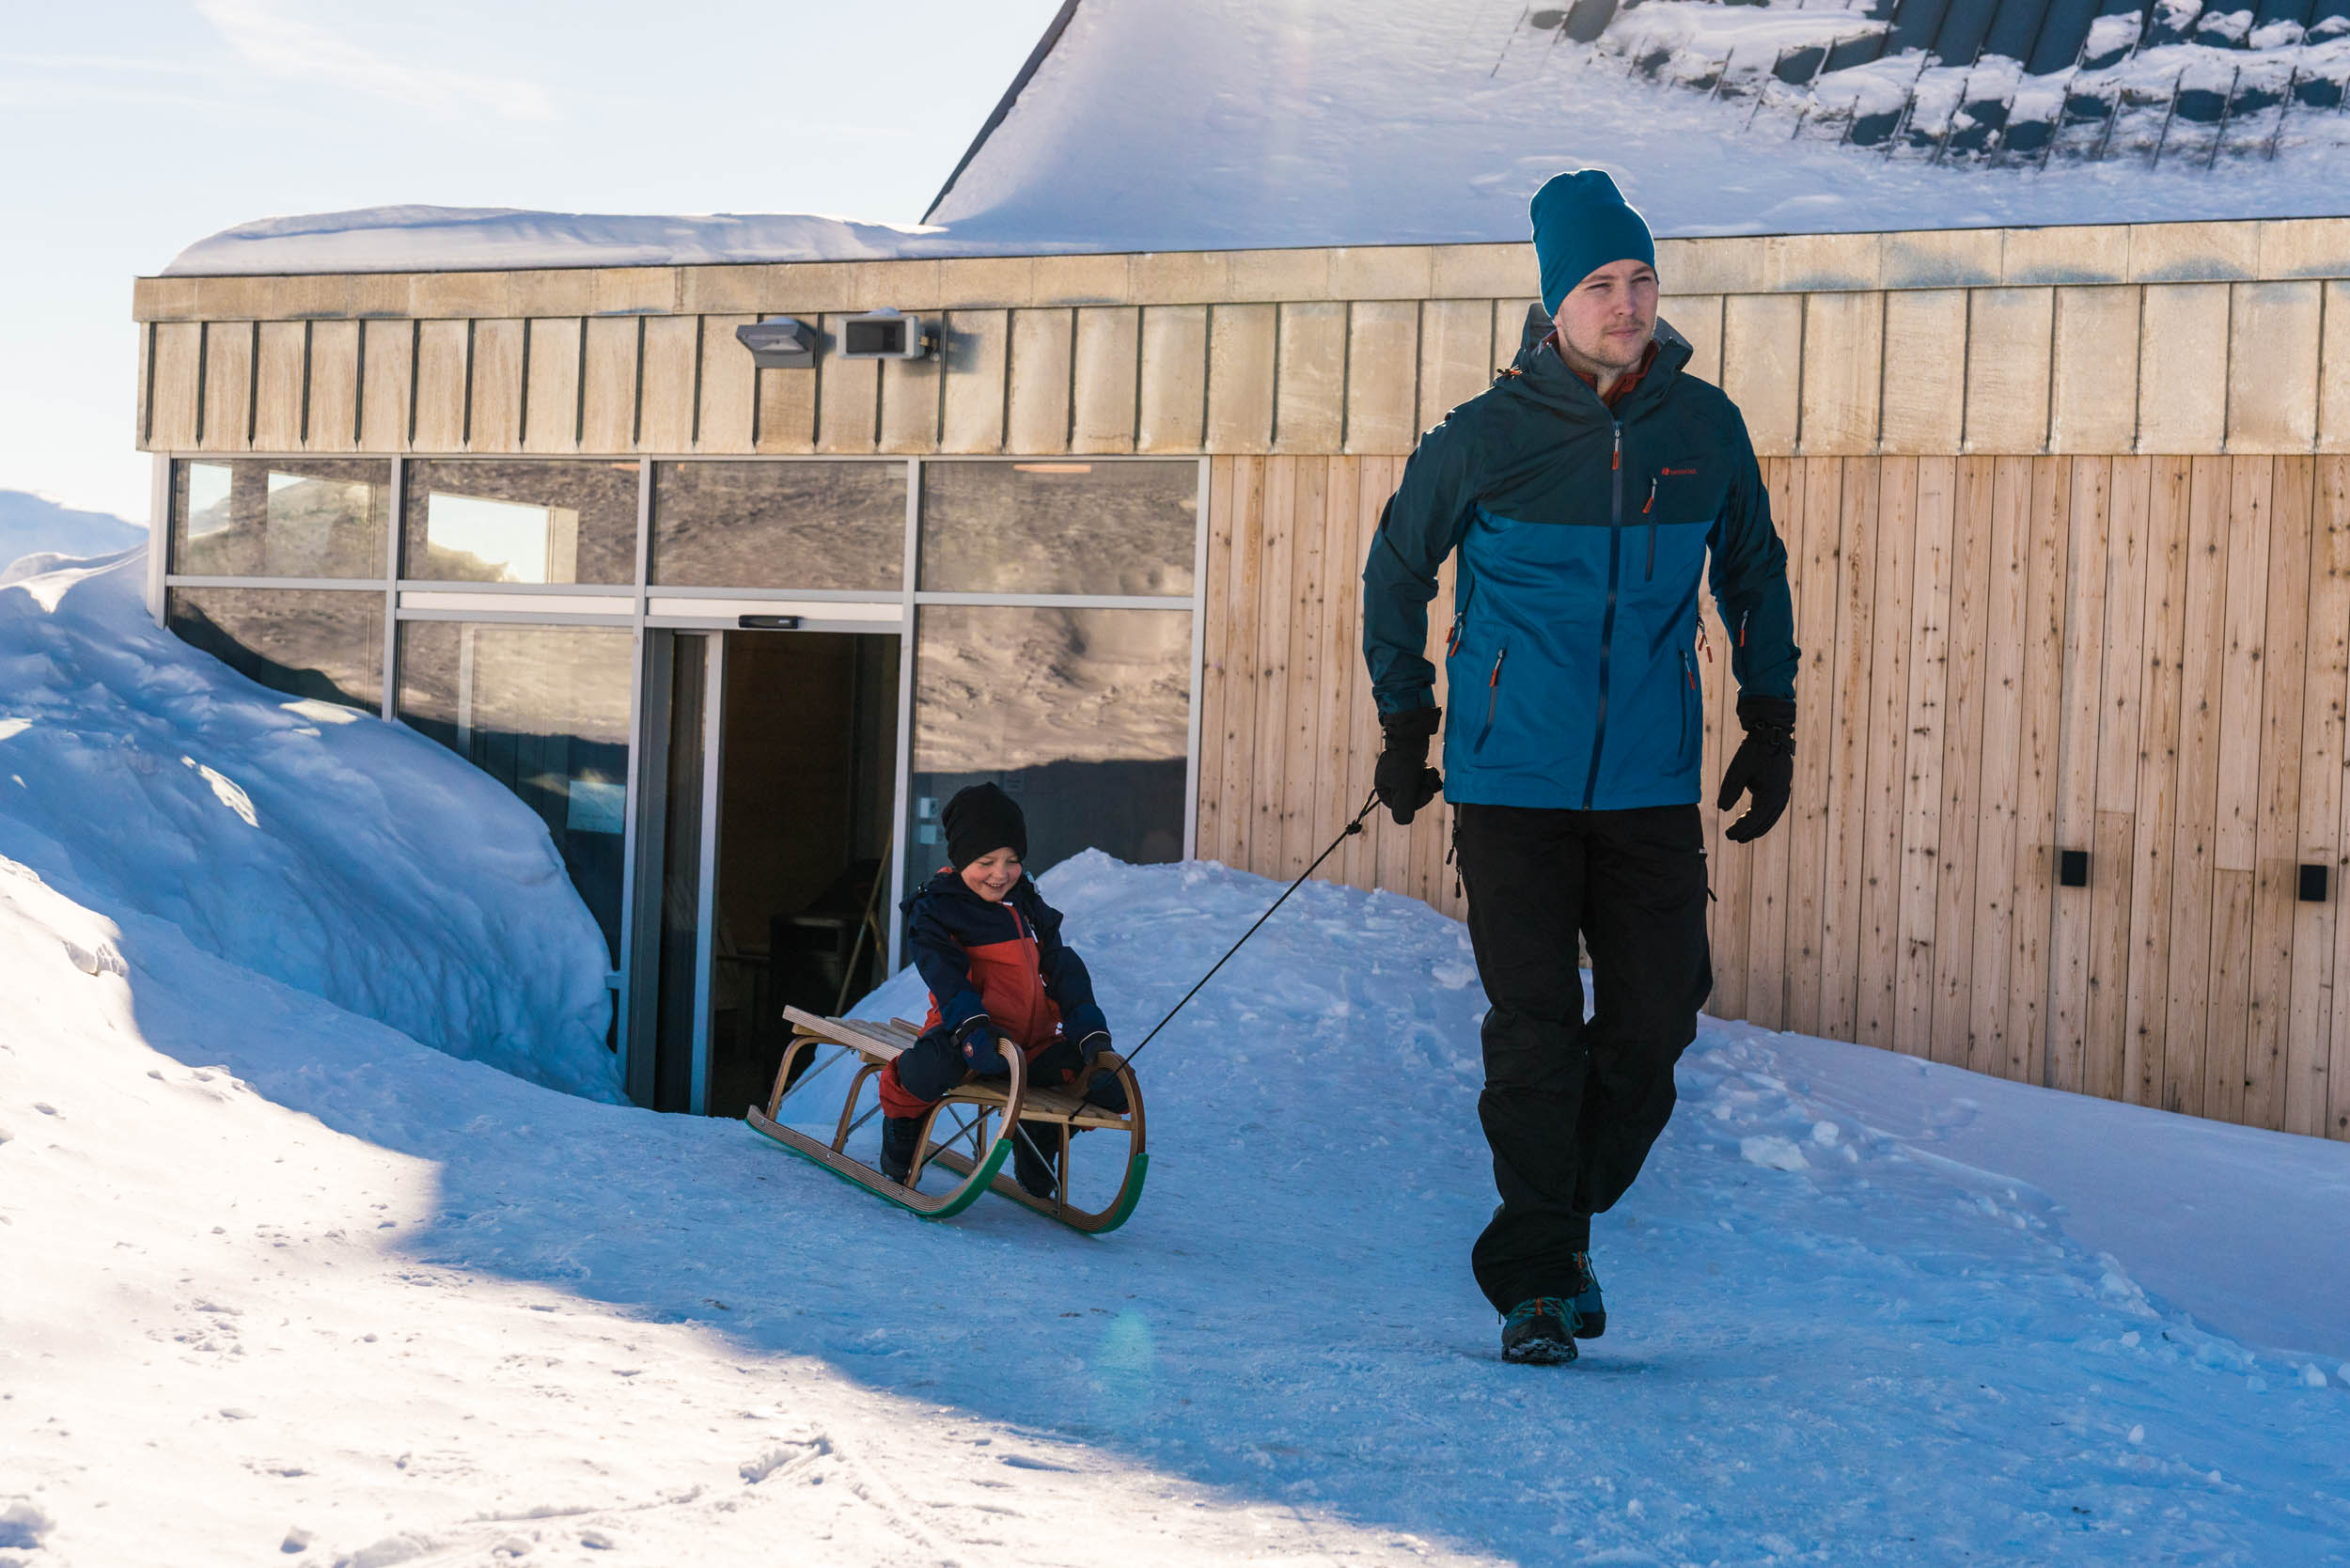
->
[929,0,2350,250]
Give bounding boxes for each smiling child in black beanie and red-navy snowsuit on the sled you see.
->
[882,783,1126,1199]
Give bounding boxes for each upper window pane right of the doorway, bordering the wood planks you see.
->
[921,461,1198,597]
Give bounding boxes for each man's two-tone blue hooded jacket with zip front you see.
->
[1363,310,1800,811]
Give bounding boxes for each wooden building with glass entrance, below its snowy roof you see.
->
[123,219,2350,1137]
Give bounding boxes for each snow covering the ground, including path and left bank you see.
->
[0,602,2350,1568]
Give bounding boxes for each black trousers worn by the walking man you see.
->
[1455,807,1714,1311]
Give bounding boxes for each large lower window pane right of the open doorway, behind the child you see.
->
[907,604,1192,902]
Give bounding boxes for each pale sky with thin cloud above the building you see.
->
[0,0,1058,522]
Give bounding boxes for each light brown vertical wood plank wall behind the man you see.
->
[1198,454,2350,1137]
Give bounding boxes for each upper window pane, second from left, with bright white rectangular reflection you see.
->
[400,470,637,586]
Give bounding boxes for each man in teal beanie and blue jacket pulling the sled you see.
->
[1363,169,1798,1363]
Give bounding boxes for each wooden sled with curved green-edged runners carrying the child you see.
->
[745,1006,1150,1234]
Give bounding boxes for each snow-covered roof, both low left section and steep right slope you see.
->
[164,0,2350,275]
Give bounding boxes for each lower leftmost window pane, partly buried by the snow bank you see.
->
[164,588,384,710]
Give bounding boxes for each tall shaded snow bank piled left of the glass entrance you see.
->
[0,550,620,1100]
